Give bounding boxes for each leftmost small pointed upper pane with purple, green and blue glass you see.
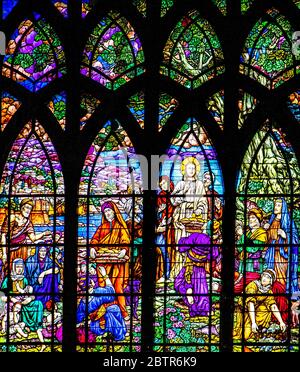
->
[2,13,65,92]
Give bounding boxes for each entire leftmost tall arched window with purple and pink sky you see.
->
[0,121,64,352]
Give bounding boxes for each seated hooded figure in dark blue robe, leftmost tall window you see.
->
[25,247,60,308]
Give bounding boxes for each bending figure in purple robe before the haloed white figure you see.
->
[174,233,219,317]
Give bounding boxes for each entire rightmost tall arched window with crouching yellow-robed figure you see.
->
[233,121,300,352]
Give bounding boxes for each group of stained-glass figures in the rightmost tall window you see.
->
[234,198,299,348]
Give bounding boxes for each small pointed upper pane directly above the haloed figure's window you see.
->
[161,11,224,89]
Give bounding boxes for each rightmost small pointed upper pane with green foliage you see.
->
[240,9,300,89]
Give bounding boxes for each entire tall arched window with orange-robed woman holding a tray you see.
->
[77,121,143,352]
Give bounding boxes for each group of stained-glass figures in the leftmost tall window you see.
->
[0,199,63,351]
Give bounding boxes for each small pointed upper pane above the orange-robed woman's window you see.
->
[81,12,145,90]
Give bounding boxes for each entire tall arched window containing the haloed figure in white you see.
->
[154,119,223,352]
